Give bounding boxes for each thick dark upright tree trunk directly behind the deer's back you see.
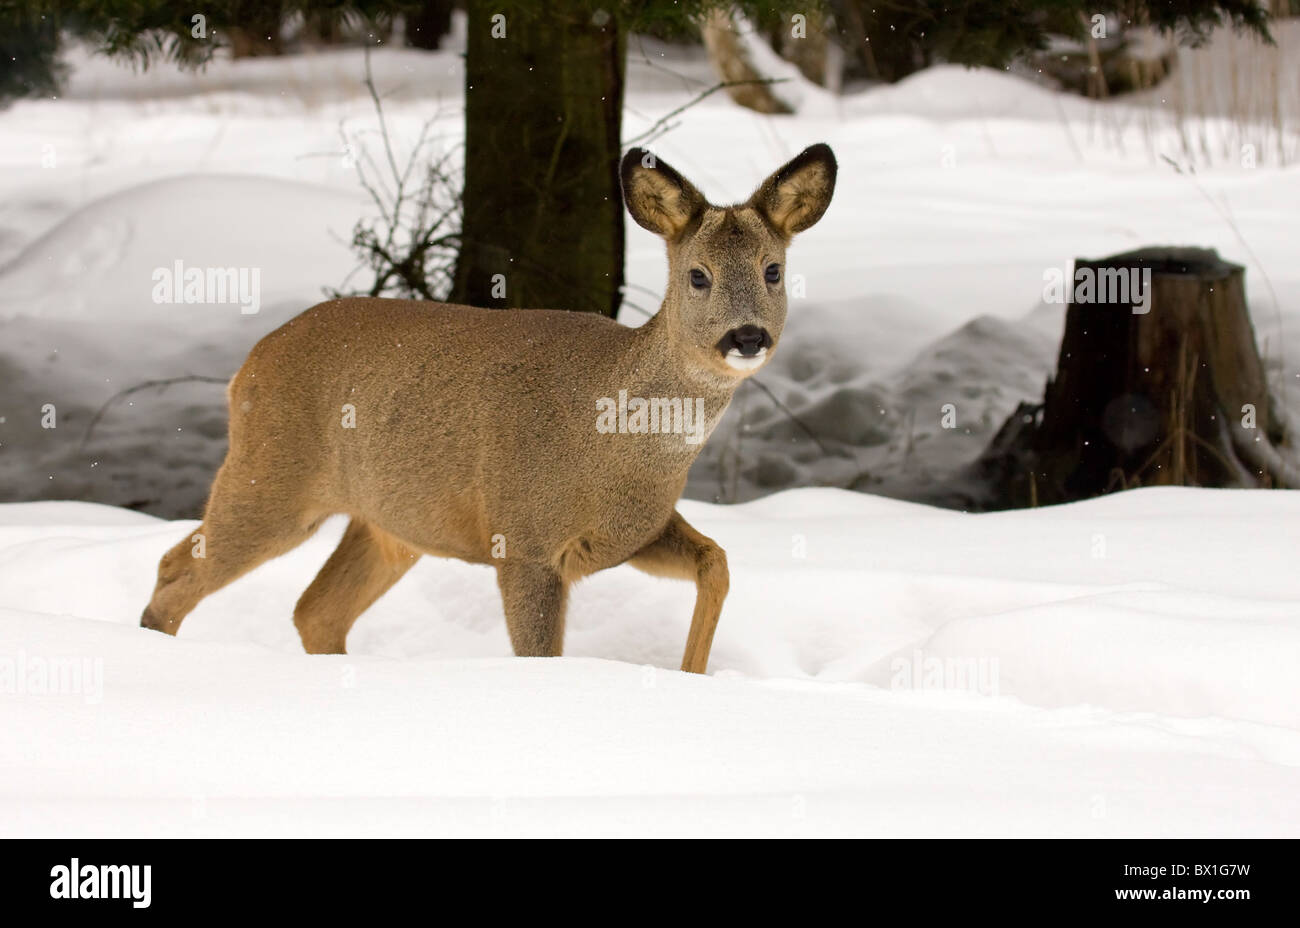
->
[452,0,625,316]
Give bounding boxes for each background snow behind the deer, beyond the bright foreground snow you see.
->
[0,19,1300,517]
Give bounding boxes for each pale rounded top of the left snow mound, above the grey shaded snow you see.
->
[0,174,363,324]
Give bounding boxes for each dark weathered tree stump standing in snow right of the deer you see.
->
[976,247,1297,508]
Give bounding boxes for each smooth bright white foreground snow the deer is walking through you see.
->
[0,489,1300,836]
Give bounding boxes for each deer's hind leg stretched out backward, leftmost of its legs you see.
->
[140,465,322,634]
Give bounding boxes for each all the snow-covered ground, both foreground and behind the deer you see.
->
[0,21,1300,836]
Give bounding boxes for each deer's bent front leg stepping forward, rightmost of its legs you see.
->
[628,512,731,673]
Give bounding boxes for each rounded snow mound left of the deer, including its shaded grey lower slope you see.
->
[0,175,361,516]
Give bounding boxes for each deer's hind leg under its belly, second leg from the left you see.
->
[294,519,420,654]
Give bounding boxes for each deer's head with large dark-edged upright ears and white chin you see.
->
[621,144,836,378]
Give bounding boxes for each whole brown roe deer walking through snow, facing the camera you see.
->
[140,144,837,673]
